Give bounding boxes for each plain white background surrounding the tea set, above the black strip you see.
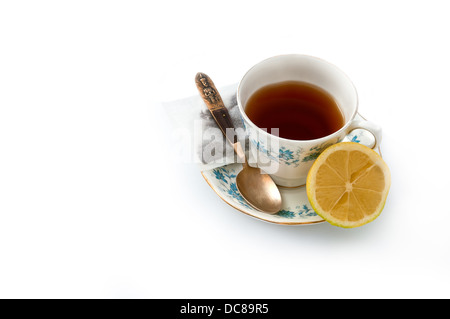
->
[0,0,450,298]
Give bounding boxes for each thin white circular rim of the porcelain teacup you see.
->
[236,53,359,143]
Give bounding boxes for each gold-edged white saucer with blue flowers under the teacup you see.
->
[202,115,381,225]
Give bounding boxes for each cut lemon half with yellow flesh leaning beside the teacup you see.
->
[306,142,391,228]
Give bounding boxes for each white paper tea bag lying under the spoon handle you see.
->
[162,84,253,171]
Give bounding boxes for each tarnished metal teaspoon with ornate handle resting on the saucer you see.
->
[195,72,281,214]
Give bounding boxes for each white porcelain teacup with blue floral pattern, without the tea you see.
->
[237,54,381,187]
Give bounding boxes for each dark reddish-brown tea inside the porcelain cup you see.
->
[245,81,344,140]
